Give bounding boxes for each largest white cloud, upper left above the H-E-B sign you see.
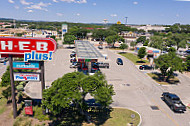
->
[26,2,51,11]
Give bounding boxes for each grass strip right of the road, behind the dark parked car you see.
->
[119,53,149,65]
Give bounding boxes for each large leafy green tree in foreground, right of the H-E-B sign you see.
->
[42,72,114,115]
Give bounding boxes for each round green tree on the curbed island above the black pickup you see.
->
[155,52,184,81]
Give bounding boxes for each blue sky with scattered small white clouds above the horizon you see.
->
[0,0,190,25]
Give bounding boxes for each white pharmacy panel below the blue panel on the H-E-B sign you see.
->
[14,73,40,81]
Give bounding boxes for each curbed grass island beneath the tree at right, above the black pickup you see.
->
[147,73,179,85]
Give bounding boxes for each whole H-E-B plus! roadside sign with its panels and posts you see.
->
[0,37,57,118]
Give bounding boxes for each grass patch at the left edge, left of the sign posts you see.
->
[0,87,7,114]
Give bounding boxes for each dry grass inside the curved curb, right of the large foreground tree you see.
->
[83,108,140,126]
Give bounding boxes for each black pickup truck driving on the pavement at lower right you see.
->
[162,92,186,112]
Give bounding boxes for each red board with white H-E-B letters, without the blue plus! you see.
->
[0,37,57,54]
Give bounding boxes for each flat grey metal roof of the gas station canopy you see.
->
[75,40,103,59]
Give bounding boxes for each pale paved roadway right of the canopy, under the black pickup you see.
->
[101,50,190,126]
